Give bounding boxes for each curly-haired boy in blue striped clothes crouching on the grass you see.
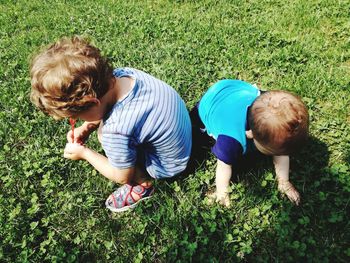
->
[30,37,192,212]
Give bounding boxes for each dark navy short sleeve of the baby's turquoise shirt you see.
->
[211,135,242,165]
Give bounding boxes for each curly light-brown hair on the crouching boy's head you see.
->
[30,37,112,119]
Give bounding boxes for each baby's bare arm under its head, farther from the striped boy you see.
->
[273,155,300,205]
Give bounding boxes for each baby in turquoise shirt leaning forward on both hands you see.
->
[191,80,308,206]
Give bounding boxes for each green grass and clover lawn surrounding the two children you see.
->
[0,0,350,262]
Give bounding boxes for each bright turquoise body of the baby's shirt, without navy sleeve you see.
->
[198,79,260,154]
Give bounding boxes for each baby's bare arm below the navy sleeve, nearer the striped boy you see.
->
[209,159,232,206]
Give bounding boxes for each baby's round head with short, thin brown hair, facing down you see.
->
[249,90,309,155]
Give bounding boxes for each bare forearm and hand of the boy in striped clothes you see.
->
[64,144,135,184]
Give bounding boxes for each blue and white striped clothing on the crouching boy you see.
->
[102,68,192,178]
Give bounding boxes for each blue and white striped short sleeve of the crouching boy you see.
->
[102,133,137,169]
